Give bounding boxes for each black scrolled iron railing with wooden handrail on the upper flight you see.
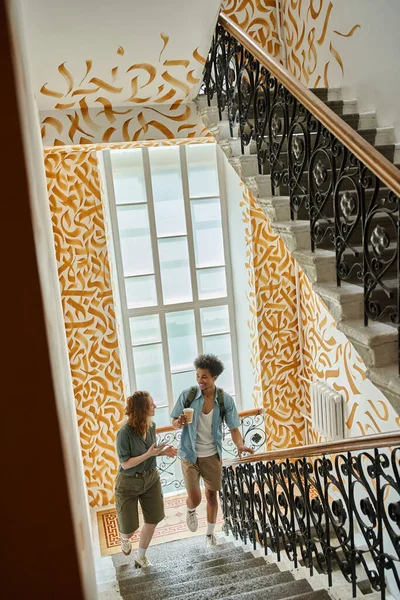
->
[202,14,400,365]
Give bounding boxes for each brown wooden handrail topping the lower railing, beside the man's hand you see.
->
[224,431,400,467]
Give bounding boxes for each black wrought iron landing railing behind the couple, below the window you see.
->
[157,409,266,494]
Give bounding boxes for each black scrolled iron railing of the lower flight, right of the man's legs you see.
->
[221,433,400,599]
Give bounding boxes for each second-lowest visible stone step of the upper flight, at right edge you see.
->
[337,320,398,367]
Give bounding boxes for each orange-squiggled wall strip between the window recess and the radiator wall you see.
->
[242,187,305,449]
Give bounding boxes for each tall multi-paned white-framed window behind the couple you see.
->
[104,144,239,426]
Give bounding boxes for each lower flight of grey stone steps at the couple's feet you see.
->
[99,535,380,600]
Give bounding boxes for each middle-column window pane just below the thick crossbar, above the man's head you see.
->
[166,310,197,371]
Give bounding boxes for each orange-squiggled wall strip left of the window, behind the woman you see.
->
[44,138,216,507]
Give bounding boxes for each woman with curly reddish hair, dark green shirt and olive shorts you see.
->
[115,392,177,567]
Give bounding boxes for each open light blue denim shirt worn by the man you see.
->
[171,388,240,463]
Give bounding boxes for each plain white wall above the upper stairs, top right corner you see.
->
[310,0,400,142]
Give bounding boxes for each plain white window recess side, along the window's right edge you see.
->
[217,146,255,410]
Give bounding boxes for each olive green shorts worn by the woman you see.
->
[115,469,165,533]
